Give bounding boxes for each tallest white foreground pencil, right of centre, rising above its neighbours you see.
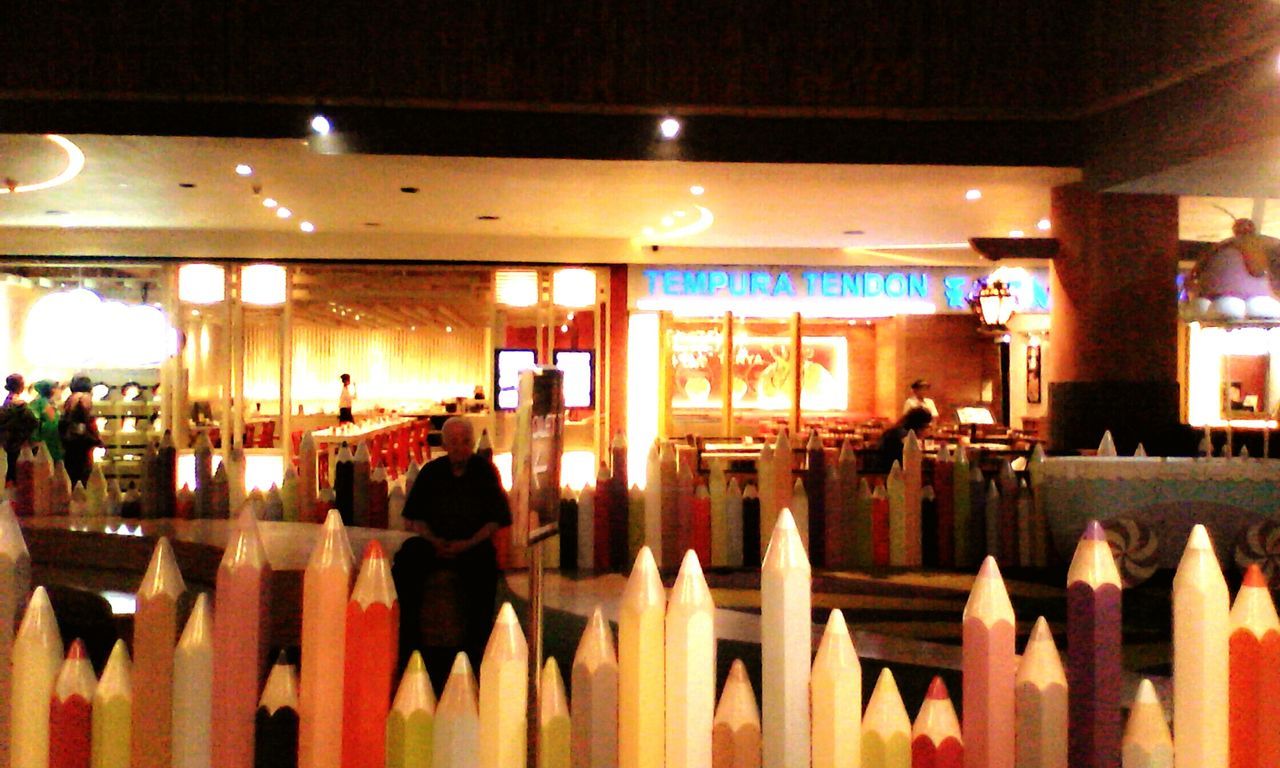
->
[760,509,813,768]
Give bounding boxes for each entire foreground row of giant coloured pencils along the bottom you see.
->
[0,481,1280,768]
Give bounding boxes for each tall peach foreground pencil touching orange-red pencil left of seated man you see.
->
[298,509,355,768]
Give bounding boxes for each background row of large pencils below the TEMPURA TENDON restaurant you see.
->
[555,430,1051,571]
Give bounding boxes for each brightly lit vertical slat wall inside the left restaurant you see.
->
[244,317,489,412]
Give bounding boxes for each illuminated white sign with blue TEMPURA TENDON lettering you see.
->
[630,266,1048,317]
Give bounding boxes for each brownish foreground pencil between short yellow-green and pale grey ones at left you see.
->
[133,536,187,768]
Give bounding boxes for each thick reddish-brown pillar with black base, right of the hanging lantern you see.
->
[1046,184,1179,452]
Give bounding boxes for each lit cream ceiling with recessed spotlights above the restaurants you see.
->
[0,134,1280,264]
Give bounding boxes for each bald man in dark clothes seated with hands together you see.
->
[393,416,511,686]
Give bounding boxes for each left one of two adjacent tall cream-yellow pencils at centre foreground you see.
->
[618,547,667,768]
